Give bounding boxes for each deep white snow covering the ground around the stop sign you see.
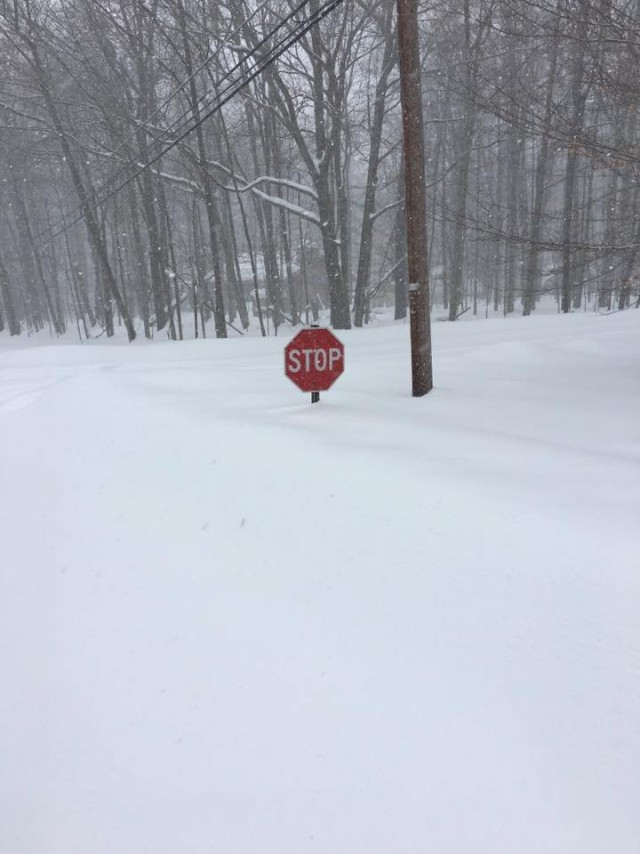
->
[0,311,640,854]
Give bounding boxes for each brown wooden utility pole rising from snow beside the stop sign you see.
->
[397,0,433,397]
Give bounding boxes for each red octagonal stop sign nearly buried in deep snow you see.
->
[284,329,344,391]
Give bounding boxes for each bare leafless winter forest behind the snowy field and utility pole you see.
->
[0,0,640,340]
